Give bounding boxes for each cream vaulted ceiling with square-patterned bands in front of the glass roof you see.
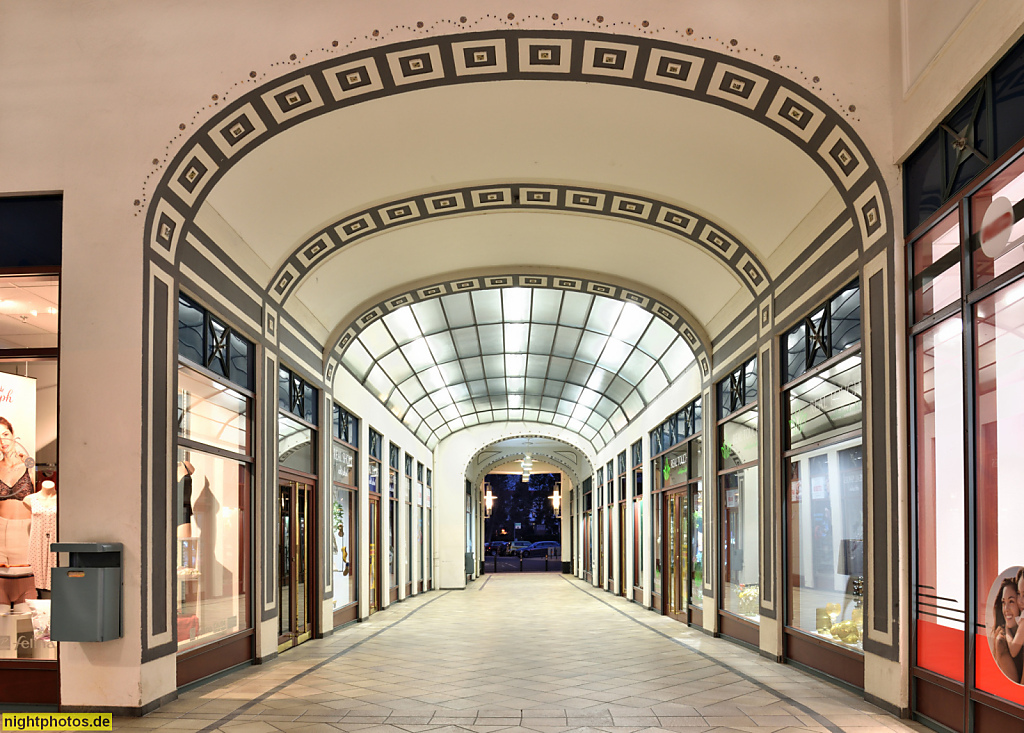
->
[147,32,891,452]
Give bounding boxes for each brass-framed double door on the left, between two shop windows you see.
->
[278,480,315,652]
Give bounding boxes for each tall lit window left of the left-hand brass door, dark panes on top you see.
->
[174,296,254,652]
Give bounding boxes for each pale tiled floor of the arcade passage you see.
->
[114,573,925,733]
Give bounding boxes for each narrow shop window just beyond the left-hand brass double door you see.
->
[331,404,359,611]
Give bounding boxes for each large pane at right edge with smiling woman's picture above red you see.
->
[974,282,1024,704]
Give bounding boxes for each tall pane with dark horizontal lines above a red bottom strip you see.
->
[914,313,967,682]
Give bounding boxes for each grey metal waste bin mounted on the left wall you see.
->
[50,543,122,642]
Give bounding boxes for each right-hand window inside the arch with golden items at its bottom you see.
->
[782,284,864,650]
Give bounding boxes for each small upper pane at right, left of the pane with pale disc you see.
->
[911,209,961,318]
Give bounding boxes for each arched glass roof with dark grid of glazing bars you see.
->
[342,287,693,449]
